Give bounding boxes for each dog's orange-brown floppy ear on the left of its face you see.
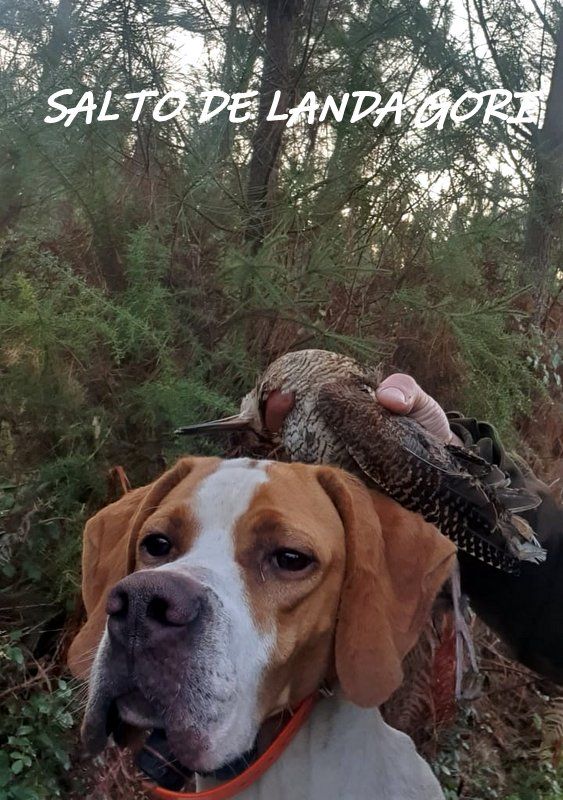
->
[67,458,197,678]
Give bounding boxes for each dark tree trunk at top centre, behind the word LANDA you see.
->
[246,0,303,250]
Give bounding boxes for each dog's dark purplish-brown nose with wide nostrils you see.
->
[106,570,206,640]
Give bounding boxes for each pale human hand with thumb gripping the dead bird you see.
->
[376,372,462,445]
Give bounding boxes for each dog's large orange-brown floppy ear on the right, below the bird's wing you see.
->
[319,468,456,706]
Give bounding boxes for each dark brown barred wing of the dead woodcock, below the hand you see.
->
[318,381,537,569]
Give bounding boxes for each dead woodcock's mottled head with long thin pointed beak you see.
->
[176,350,365,443]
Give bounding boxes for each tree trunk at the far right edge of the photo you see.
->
[524,15,563,325]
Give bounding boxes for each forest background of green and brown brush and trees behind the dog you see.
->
[0,0,563,800]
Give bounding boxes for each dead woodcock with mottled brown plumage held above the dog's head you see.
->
[176,350,545,572]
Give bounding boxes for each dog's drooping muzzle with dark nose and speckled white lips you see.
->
[83,569,235,768]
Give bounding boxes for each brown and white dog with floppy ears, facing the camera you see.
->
[69,458,455,800]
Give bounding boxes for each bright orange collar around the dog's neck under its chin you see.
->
[149,692,320,800]
